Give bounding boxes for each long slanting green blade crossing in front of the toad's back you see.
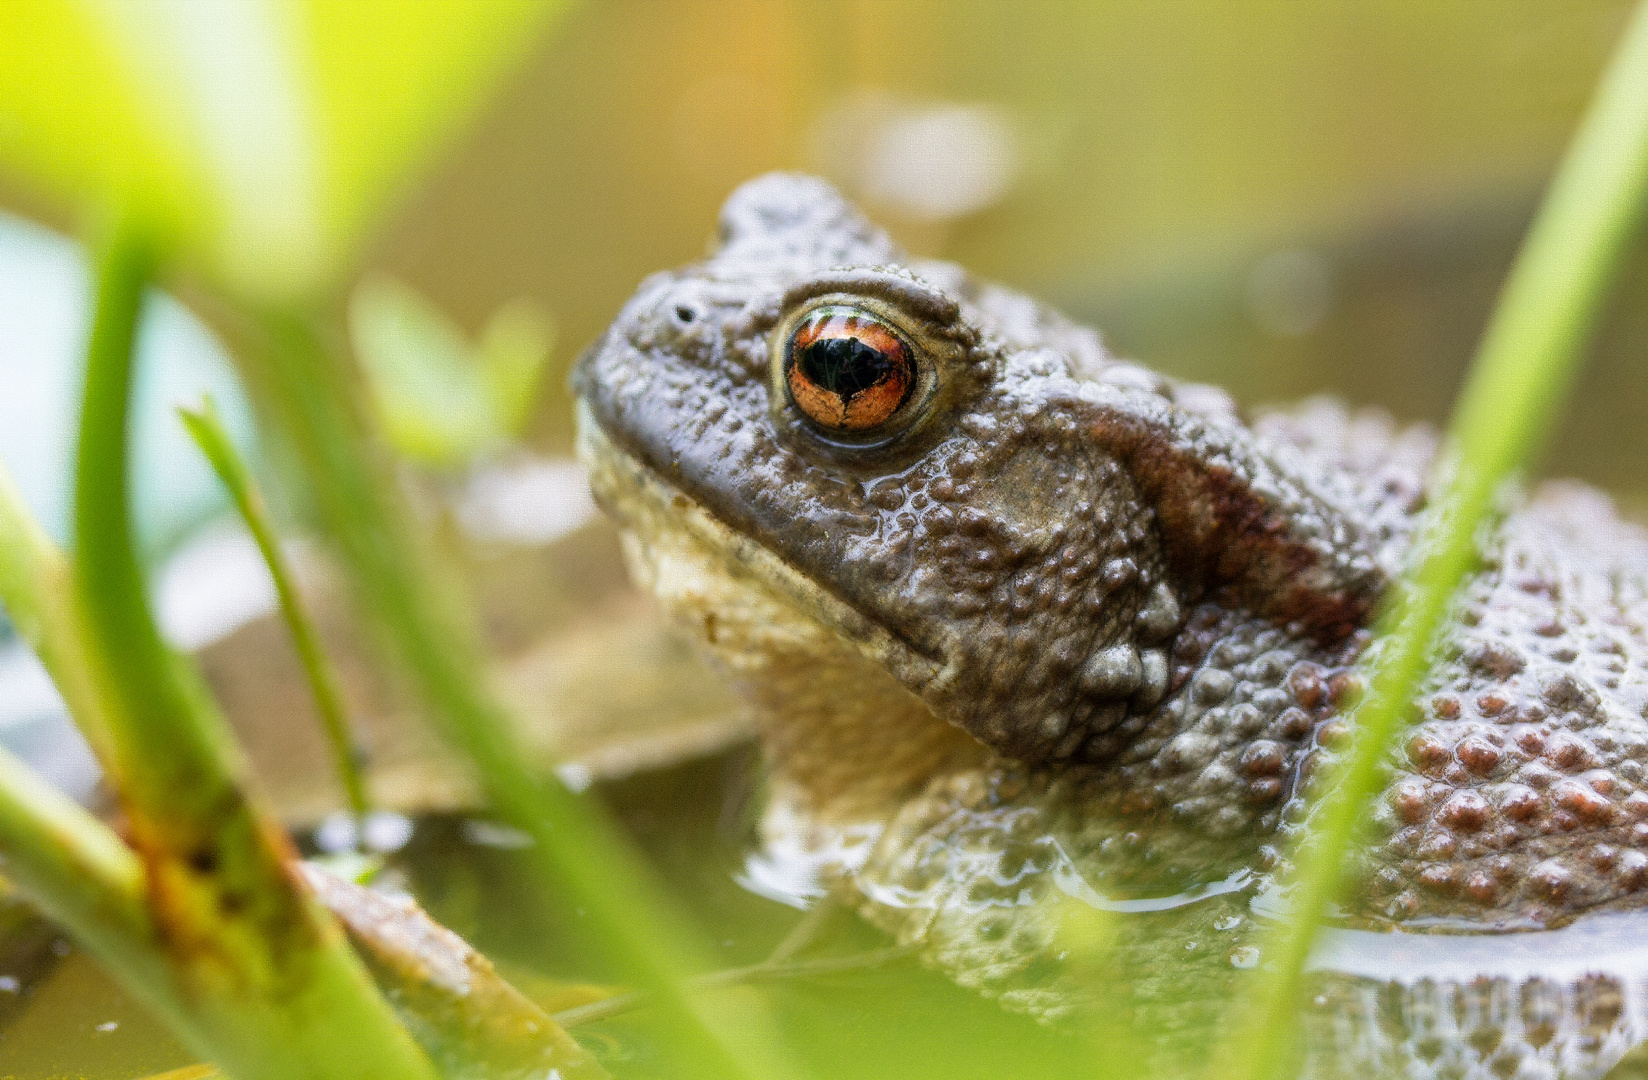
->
[1216,3,1648,1080]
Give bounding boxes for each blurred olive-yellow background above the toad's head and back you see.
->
[357,0,1648,508]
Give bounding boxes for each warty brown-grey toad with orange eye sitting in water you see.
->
[575,175,1648,1075]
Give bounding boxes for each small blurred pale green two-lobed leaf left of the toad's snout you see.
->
[349,277,552,468]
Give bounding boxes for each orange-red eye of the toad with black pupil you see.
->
[784,307,916,432]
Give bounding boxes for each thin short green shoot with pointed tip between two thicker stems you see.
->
[178,401,369,818]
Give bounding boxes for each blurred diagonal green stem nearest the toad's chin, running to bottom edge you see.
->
[240,306,796,1080]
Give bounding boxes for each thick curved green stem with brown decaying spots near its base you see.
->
[74,221,435,1080]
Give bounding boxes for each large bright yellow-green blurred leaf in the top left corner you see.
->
[0,0,562,297]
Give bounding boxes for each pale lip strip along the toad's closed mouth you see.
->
[575,397,953,693]
